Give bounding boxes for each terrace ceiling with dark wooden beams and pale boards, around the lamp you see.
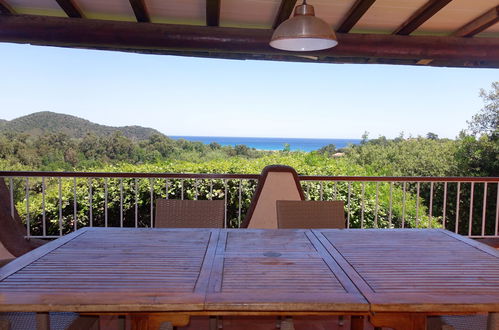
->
[0,0,499,68]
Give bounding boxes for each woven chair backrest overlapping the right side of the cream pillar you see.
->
[276,201,345,229]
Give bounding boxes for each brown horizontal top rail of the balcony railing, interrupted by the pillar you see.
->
[0,171,499,183]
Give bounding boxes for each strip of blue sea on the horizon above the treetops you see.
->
[169,136,361,152]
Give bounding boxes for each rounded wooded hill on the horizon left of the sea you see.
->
[0,111,164,140]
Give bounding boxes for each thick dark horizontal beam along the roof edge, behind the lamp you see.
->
[0,15,499,67]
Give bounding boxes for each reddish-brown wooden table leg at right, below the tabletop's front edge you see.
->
[369,313,426,330]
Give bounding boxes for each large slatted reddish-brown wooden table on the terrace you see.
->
[0,228,499,329]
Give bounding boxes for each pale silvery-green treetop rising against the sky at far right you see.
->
[468,81,499,137]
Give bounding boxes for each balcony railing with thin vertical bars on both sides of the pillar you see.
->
[0,172,499,238]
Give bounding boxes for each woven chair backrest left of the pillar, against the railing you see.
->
[154,199,225,228]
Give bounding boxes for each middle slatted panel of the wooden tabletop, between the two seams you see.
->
[206,229,368,312]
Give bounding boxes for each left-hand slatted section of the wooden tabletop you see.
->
[0,228,218,312]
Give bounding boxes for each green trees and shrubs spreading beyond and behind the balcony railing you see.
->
[0,83,499,234]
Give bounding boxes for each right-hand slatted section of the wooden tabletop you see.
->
[315,229,499,313]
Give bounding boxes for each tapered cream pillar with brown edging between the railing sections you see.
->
[241,165,305,229]
